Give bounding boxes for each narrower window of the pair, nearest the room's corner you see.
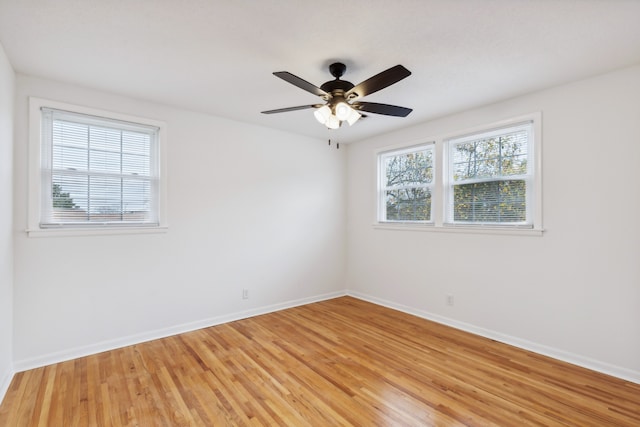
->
[379,146,433,222]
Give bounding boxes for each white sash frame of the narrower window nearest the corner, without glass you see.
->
[378,142,437,224]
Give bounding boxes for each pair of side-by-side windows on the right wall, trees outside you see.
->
[377,113,542,234]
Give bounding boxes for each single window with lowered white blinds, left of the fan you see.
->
[30,99,163,236]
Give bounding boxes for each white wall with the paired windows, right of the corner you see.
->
[347,66,640,382]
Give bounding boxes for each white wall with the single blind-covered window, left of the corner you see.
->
[14,75,346,369]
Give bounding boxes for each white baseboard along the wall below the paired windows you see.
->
[347,291,640,384]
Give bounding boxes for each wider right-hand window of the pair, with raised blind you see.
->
[446,123,533,227]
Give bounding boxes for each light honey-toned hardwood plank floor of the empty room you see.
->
[0,297,640,427]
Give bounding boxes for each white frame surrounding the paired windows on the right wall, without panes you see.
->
[373,112,544,236]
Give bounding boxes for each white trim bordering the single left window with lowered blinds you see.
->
[26,97,168,237]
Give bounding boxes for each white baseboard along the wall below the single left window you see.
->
[13,291,346,374]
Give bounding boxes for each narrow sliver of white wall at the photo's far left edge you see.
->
[0,45,15,402]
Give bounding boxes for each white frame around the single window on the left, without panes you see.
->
[27,97,167,237]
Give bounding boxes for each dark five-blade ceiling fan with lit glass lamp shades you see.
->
[262,62,412,129]
